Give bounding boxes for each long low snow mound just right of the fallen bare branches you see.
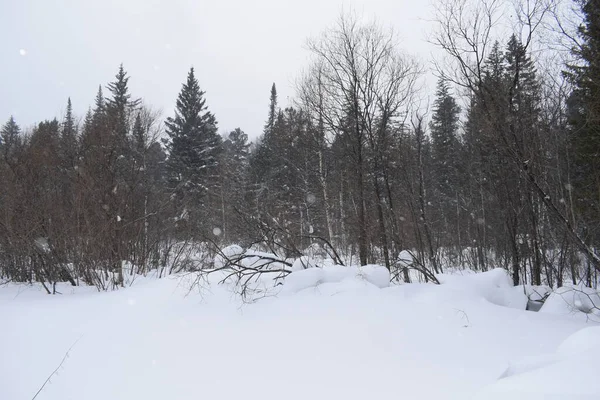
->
[282,263,390,294]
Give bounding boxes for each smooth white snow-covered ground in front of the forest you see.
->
[0,266,600,400]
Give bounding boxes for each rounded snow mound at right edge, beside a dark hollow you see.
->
[540,286,600,321]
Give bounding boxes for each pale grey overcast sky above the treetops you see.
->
[0,0,432,137]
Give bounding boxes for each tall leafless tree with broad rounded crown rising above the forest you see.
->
[301,14,421,268]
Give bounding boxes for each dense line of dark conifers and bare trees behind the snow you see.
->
[0,0,600,292]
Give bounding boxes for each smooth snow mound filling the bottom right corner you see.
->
[475,326,600,400]
